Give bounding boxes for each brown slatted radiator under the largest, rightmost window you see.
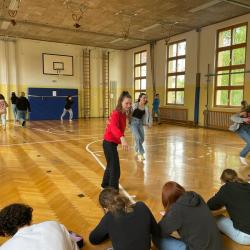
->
[203,110,235,130]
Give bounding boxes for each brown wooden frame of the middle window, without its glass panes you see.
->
[166,39,187,106]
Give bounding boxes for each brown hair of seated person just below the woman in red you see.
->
[99,188,133,215]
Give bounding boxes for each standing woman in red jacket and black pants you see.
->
[101,91,132,189]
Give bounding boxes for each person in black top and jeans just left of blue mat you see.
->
[16,92,31,127]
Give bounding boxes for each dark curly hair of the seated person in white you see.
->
[0,203,33,236]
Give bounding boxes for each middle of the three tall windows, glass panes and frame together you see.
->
[167,40,186,105]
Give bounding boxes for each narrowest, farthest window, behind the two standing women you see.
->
[134,51,147,100]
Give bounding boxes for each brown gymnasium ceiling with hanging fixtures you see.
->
[0,0,250,49]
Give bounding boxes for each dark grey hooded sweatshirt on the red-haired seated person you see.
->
[159,192,223,250]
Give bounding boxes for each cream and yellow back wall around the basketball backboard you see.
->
[0,39,125,117]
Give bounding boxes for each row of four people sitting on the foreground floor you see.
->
[0,169,250,250]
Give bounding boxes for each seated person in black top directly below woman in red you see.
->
[89,188,160,250]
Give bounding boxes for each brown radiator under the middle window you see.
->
[160,107,188,122]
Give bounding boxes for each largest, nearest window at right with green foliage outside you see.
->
[215,24,247,107]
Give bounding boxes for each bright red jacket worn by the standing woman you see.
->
[104,110,127,144]
